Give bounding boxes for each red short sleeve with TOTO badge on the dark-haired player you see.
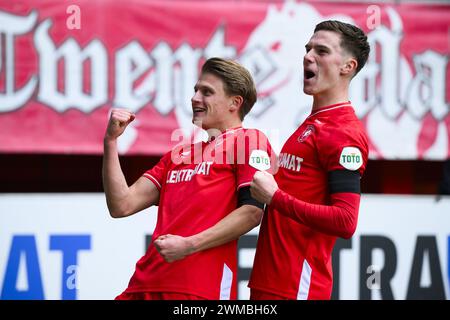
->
[316,122,369,176]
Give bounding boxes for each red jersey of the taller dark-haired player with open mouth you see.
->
[249,102,368,299]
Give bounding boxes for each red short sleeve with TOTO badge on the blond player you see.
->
[235,129,277,190]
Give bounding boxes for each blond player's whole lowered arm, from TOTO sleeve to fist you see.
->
[154,129,276,262]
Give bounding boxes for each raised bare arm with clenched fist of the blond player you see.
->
[102,109,159,218]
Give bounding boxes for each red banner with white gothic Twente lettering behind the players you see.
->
[0,0,450,160]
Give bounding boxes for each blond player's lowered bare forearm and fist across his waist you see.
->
[154,205,263,262]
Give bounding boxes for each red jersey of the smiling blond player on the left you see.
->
[126,128,274,300]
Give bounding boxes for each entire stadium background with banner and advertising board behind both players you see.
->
[0,0,450,299]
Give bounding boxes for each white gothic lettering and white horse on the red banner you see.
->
[0,1,449,159]
